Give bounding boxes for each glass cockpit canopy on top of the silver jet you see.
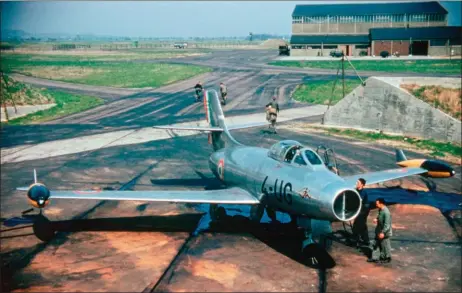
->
[268,140,324,167]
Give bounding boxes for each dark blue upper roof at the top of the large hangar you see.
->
[292,1,448,17]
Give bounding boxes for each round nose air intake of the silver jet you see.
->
[332,189,361,221]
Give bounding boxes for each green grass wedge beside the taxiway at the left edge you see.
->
[6,90,104,125]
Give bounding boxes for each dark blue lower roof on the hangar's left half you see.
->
[290,35,369,45]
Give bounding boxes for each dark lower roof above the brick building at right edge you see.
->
[369,26,462,40]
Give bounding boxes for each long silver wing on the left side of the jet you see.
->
[34,187,260,205]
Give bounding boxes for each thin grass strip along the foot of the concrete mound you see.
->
[318,128,462,157]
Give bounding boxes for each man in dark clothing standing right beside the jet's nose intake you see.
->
[353,178,370,248]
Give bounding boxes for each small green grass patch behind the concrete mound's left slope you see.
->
[292,79,361,105]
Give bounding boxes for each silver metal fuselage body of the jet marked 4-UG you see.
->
[209,146,361,221]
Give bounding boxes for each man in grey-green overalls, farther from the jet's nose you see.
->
[367,198,392,263]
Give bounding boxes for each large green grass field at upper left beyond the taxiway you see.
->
[1,52,212,88]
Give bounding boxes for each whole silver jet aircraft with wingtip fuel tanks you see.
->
[18,90,455,266]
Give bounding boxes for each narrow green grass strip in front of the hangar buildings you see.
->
[269,59,462,74]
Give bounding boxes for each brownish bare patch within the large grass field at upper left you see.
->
[22,66,105,80]
